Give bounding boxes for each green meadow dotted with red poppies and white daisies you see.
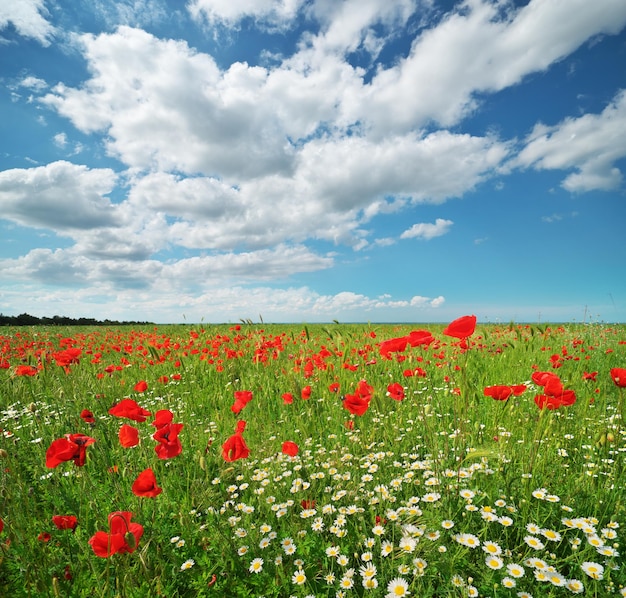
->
[0,316,626,598]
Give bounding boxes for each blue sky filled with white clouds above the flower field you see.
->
[0,0,626,323]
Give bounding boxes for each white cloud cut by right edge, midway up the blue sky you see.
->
[514,90,626,191]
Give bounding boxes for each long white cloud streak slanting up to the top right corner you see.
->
[345,0,626,135]
